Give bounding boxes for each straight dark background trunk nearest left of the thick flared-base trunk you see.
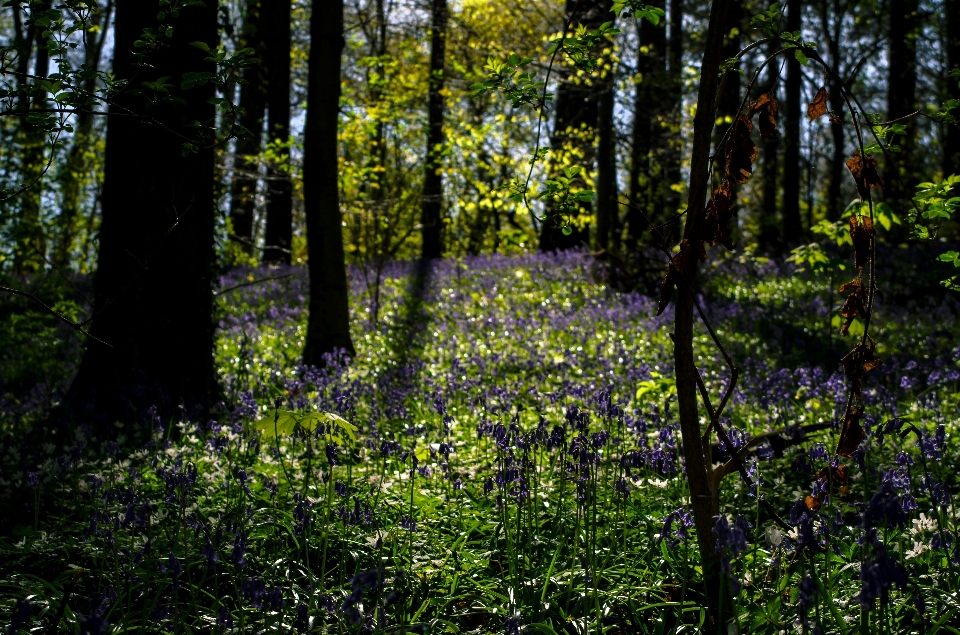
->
[261,0,293,265]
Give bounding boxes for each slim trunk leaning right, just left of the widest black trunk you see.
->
[53,0,113,269]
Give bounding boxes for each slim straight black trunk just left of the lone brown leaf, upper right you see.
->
[782,0,803,247]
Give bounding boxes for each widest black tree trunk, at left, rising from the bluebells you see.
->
[71,0,217,430]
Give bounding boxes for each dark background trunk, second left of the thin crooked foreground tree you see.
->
[627,0,671,250]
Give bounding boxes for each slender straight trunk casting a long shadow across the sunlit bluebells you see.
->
[420,0,447,259]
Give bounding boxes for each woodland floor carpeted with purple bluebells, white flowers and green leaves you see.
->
[0,253,960,634]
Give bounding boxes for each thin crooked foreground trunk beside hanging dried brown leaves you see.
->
[674,0,729,632]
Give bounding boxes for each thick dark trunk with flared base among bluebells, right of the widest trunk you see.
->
[303,0,354,366]
